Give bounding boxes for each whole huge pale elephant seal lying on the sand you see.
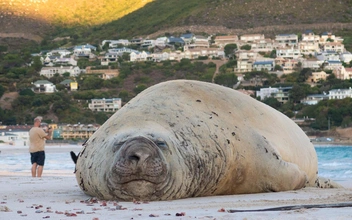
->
[73,80,340,201]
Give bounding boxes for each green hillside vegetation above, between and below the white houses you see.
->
[0,0,352,138]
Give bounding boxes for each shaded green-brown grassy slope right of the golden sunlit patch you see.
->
[89,0,352,37]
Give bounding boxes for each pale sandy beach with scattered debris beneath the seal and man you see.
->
[0,145,352,220]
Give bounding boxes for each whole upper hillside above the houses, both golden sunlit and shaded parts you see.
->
[0,0,352,44]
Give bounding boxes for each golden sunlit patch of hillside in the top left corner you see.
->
[0,0,152,25]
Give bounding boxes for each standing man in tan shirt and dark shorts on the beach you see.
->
[29,116,52,177]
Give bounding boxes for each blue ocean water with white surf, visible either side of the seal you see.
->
[0,145,352,182]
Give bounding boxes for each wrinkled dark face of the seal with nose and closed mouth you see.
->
[107,136,170,199]
